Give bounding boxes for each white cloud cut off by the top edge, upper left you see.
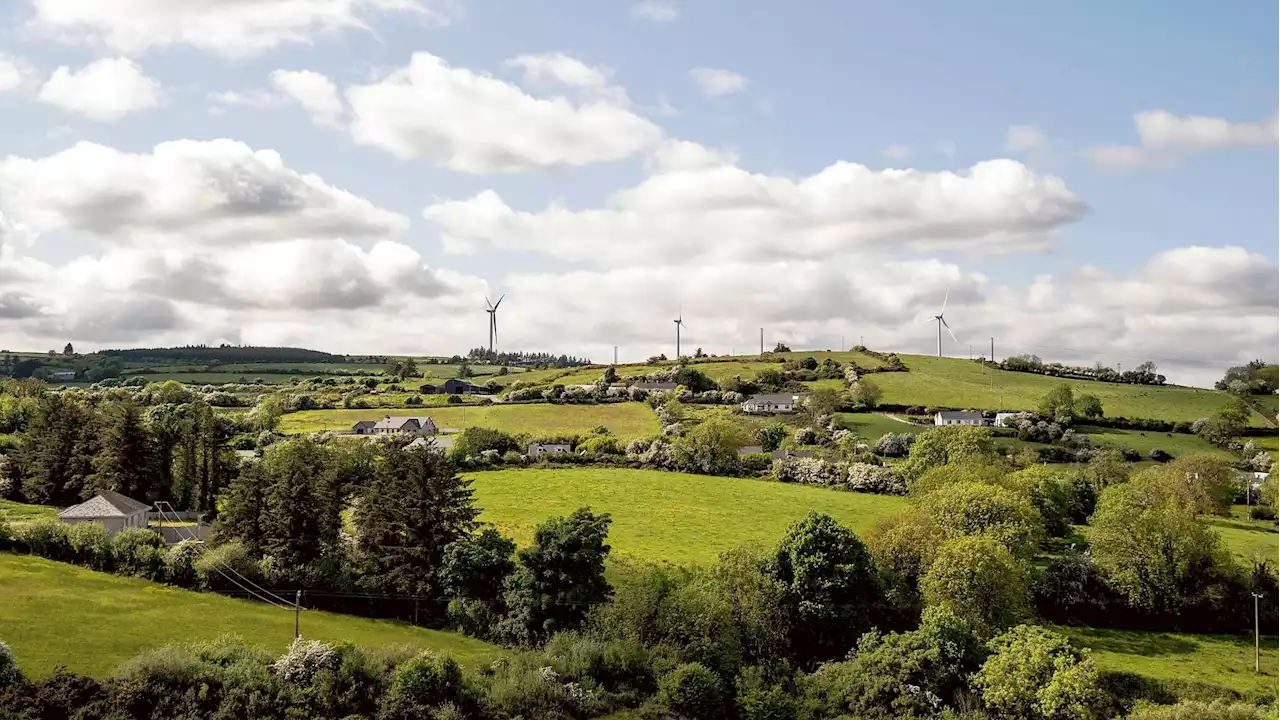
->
[32,0,449,56]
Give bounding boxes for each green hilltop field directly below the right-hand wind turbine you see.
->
[872,355,1228,421]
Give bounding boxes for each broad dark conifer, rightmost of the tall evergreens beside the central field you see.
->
[355,446,480,597]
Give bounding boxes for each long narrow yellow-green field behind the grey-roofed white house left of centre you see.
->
[280,402,660,441]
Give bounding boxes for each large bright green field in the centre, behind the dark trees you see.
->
[467,468,906,564]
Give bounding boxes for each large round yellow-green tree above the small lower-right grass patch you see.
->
[1089,482,1226,616]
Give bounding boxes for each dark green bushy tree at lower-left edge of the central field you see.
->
[499,507,613,646]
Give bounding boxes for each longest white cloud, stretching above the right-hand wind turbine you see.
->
[422,142,1084,265]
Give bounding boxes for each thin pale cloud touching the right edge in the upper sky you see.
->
[1085,110,1280,170]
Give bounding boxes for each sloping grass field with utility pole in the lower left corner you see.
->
[0,553,503,676]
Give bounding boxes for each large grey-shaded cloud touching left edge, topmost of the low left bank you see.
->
[0,140,408,246]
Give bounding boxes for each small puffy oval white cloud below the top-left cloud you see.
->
[38,58,164,122]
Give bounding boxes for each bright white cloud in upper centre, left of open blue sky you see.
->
[347,53,662,173]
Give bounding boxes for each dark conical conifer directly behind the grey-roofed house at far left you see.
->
[90,400,159,501]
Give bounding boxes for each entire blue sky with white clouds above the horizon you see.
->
[0,0,1280,383]
